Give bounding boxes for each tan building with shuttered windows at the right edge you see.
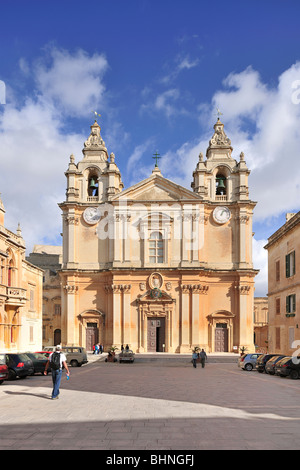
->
[265,212,300,355]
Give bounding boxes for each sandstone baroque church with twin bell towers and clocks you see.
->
[59,118,258,353]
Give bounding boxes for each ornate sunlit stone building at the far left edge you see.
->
[0,199,43,352]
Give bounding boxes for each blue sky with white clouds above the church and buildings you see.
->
[0,0,300,296]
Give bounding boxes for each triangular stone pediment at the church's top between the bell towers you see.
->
[112,175,200,202]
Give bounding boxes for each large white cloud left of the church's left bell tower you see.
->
[0,49,107,252]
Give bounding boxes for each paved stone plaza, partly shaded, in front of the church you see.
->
[0,358,300,451]
